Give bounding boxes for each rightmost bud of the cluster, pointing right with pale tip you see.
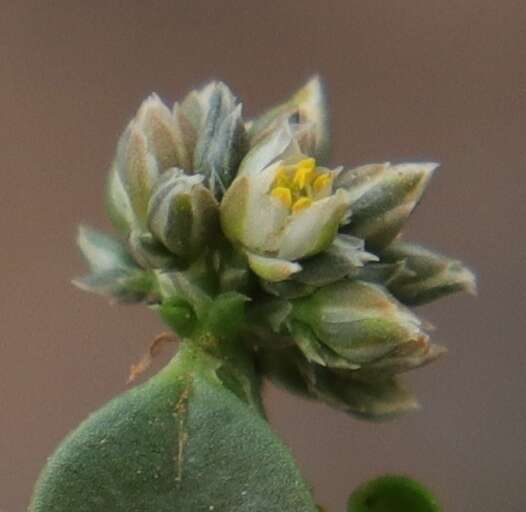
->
[381,242,476,305]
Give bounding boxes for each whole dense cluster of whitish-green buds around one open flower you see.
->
[75,78,475,418]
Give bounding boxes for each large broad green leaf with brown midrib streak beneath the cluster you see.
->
[29,343,316,512]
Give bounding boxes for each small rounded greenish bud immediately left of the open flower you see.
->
[148,169,219,258]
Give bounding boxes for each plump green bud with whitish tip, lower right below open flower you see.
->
[289,280,428,369]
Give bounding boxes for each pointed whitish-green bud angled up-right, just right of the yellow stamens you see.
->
[336,163,437,250]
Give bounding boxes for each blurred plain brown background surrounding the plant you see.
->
[0,0,526,512]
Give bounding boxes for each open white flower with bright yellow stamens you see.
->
[221,123,350,281]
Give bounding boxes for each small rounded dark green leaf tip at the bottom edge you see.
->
[347,475,442,512]
